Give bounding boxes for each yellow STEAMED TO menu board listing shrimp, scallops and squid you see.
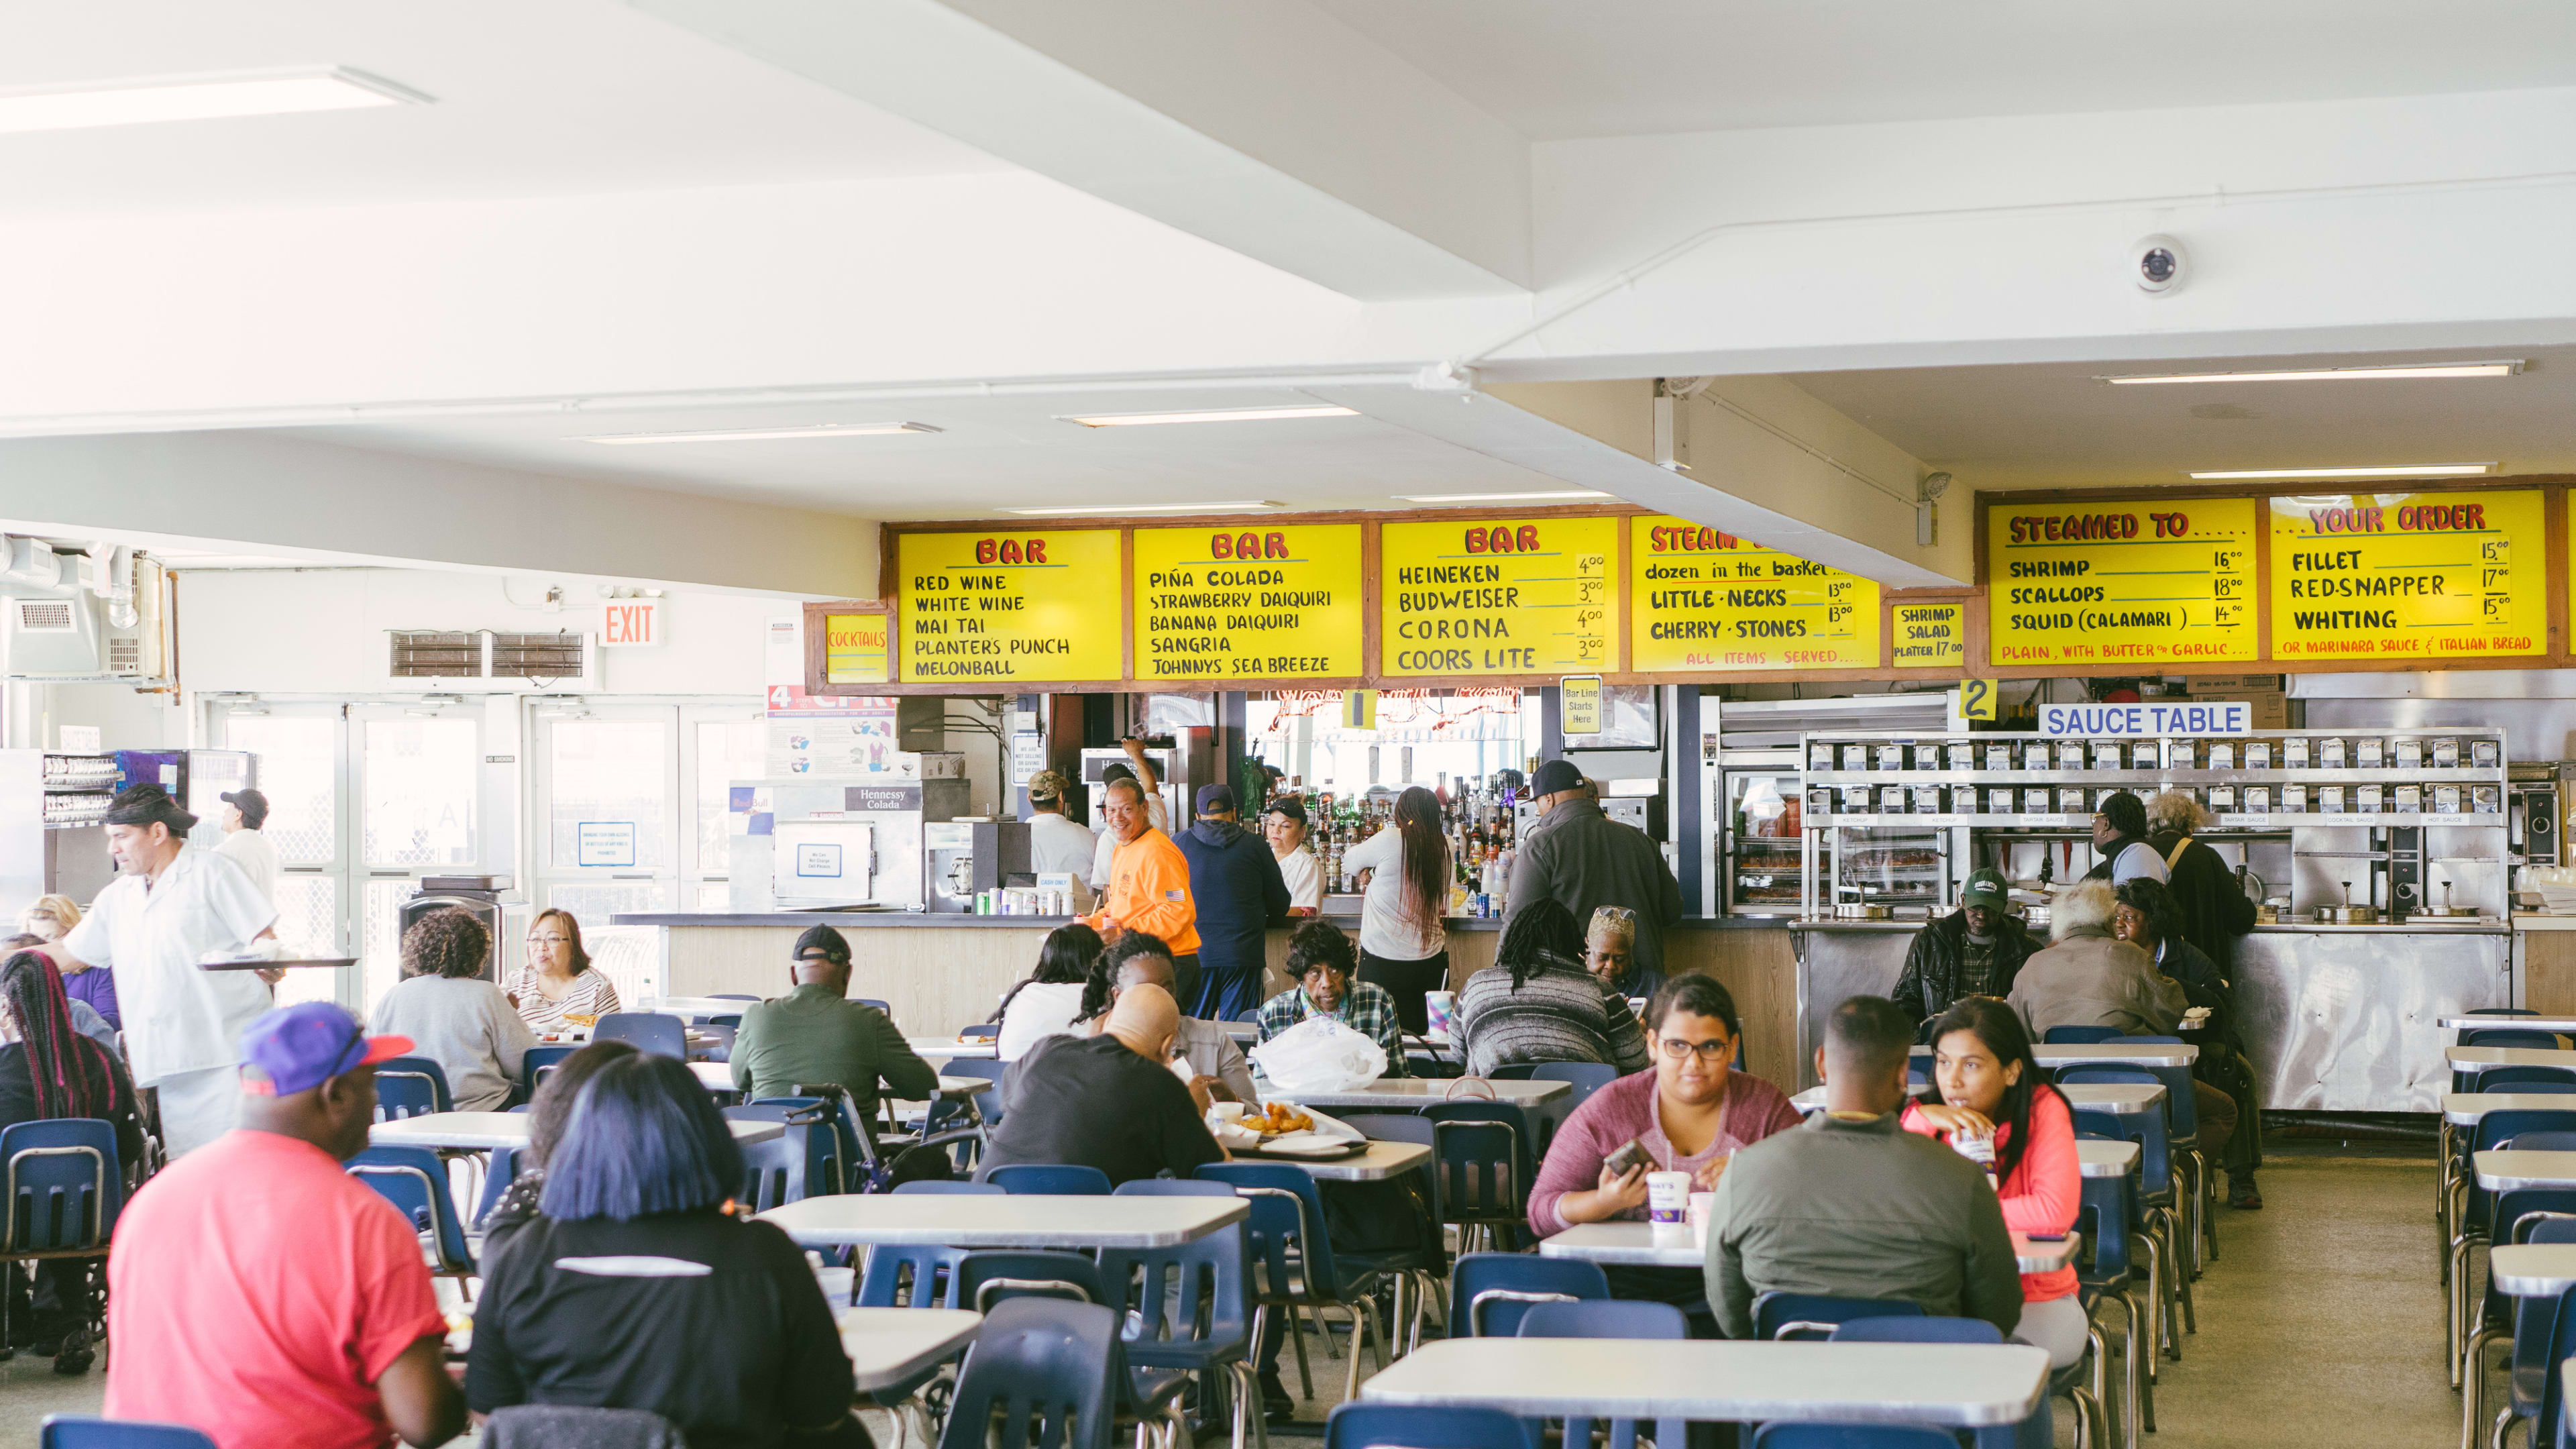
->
[1986,495,2257,667]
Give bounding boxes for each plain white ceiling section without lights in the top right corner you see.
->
[1313,0,2576,140]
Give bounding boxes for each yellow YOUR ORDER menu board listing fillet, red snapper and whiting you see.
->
[2272,490,2551,660]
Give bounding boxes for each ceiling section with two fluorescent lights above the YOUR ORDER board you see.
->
[1790,345,2576,490]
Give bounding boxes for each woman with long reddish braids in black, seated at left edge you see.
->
[0,951,144,1375]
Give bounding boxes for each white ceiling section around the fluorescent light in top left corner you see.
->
[0,0,1005,214]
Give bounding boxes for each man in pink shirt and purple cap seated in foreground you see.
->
[105,1000,466,1449]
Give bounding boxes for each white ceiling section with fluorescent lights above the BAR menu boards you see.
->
[283,387,1564,521]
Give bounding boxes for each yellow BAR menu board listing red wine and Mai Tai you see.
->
[896,526,1123,684]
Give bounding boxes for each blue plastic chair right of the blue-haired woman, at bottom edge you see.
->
[941,1297,1120,1449]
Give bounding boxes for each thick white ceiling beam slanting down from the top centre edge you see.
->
[629,0,1530,302]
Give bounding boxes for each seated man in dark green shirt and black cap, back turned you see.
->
[732,926,941,1122]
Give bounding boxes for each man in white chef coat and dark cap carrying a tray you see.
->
[44,784,278,1158]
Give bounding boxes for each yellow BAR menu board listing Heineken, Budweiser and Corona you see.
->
[1378,519,1618,676]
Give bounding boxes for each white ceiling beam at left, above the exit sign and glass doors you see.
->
[0,433,876,598]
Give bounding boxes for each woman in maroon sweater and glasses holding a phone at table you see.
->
[1530,975,1798,1336]
